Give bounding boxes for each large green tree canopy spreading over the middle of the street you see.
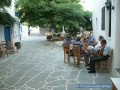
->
[16,0,92,33]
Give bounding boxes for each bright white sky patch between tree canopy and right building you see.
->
[81,0,94,11]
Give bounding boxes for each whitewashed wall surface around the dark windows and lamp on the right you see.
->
[92,0,120,74]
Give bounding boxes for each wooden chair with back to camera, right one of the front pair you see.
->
[73,46,80,65]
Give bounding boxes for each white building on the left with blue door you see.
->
[0,0,20,42]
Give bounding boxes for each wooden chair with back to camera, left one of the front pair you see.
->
[63,45,71,64]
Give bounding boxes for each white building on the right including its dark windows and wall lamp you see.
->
[92,0,120,76]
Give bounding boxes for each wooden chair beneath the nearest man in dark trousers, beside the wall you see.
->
[98,49,113,73]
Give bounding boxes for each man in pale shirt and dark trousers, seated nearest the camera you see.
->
[88,39,111,73]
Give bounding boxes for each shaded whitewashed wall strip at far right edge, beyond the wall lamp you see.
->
[112,0,120,68]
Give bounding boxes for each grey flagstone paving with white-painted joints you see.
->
[0,36,111,90]
